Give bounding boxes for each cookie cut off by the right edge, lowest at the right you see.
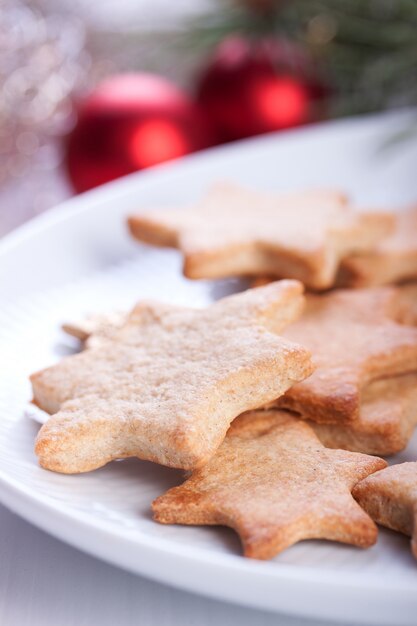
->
[353,463,417,559]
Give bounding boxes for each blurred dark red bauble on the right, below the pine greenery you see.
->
[197,37,325,141]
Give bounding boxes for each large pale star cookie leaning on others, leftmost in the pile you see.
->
[31,281,312,473]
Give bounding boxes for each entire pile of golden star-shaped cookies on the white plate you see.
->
[31,184,417,559]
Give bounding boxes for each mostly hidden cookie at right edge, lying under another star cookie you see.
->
[309,372,417,456]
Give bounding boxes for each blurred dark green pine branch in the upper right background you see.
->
[184,0,417,115]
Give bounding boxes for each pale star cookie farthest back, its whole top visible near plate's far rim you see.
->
[129,183,394,289]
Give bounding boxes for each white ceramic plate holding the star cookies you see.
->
[0,116,417,625]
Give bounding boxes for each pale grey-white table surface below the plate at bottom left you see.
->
[0,506,358,626]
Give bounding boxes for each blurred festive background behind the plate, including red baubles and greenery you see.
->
[0,0,417,235]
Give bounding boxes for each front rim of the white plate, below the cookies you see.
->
[0,458,416,626]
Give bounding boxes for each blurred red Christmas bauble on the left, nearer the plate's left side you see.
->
[66,73,213,192]
